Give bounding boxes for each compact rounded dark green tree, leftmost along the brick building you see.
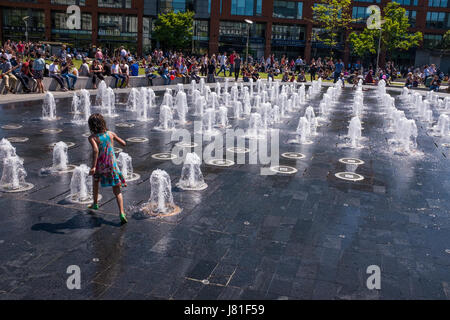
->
[153,11,194,50]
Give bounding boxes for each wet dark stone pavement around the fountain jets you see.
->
[0,88,450,299]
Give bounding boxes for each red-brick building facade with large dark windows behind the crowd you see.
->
[0,0,450,61]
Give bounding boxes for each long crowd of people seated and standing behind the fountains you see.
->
[0,40,450,93]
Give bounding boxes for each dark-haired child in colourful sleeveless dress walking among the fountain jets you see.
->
[88,113,128,224]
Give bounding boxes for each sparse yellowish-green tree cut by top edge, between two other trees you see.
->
[312,0,357,56]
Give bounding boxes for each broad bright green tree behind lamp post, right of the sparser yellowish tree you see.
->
[349,2,422,62]
